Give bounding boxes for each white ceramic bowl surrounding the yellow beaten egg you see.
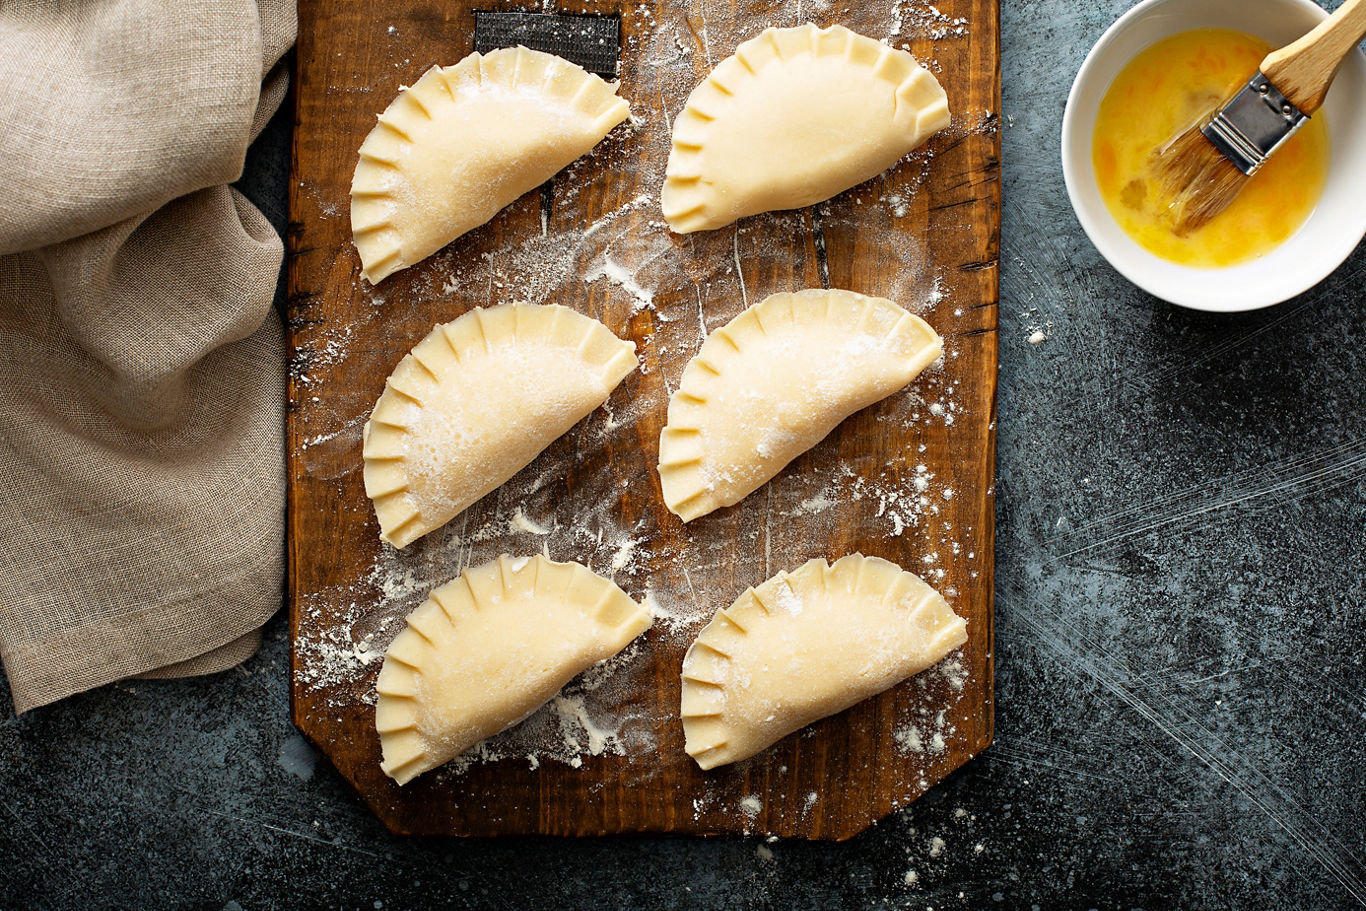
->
[1063,0,1366,313]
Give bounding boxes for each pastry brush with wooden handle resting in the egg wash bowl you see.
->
[1157,0,1366,235]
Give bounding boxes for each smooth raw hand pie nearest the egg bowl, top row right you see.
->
[661,25,949,234]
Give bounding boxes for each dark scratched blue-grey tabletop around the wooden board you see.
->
[0,0,1366,911]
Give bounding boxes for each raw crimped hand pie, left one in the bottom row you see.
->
[374,555,650,784]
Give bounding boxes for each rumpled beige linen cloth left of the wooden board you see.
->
[0,0,295,712]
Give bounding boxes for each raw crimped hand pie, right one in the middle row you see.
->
[660,290,944,522]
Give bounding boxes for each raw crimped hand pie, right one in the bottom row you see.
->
[683,555,967,769]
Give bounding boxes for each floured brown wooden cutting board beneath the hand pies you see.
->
[288,0,1000,839]
